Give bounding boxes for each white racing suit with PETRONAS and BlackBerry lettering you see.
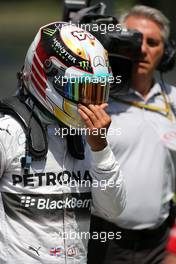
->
[0,116,125,264]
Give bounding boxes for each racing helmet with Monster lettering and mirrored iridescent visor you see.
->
[22,22,112,128]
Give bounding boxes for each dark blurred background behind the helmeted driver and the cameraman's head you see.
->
[0,0,176,98]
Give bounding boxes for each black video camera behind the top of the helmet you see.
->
[63,0,142,59]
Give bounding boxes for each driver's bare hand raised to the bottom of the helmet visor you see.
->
[78,103,111,151]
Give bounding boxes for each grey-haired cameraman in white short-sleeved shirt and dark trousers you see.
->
[88,6,176,264]
